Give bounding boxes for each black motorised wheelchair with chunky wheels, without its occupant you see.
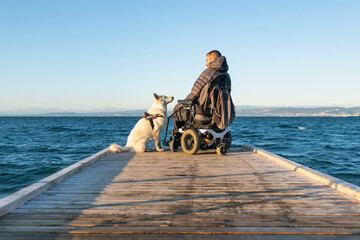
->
[163,100,231,156]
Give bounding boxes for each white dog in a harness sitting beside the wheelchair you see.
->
[110,93,174,152]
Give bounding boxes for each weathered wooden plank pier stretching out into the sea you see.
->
[0,146,360,240]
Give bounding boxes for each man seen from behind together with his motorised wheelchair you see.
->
[164,50,235,155]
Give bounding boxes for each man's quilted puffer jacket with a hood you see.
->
[185,56,231,100]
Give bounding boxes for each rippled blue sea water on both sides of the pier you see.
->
[0,117,360,198]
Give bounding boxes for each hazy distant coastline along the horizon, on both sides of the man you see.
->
[0,106,360,117]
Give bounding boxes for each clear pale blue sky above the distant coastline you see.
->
[0,0,360,111]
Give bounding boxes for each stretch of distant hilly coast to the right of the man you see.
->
[236,107,360,117]
